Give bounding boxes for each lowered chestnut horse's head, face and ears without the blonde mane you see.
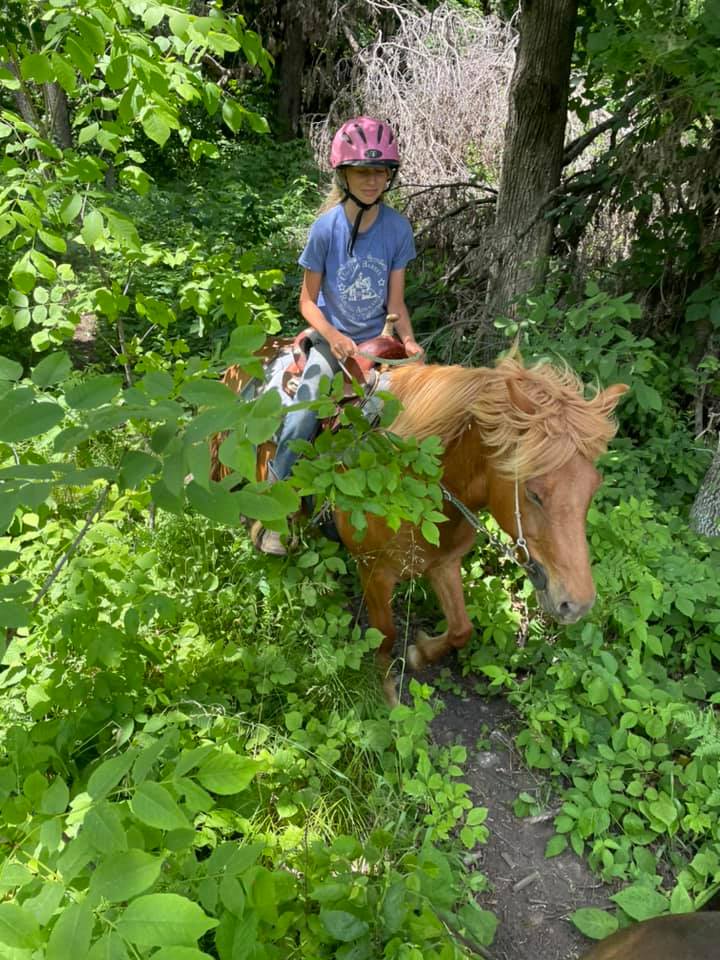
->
[487,379,628,623]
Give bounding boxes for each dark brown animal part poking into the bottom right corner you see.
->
[581,911,720,960]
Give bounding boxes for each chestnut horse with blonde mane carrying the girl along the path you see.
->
[335,356,628,702]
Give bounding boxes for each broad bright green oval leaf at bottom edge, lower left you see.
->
[114,893,218,944]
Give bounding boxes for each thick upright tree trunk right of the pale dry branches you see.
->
[487,0,577,317]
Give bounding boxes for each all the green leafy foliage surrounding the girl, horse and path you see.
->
[0,0,720,960]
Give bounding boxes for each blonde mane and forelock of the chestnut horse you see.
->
[389,355,617,480]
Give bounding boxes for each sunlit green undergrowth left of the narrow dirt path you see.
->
[0,496,495,960]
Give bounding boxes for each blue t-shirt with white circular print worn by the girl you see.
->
[298,203,415,343]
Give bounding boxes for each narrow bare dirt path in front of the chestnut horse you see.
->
[418,671,613,960]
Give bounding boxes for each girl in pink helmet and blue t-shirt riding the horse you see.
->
[256,117,423,556]
